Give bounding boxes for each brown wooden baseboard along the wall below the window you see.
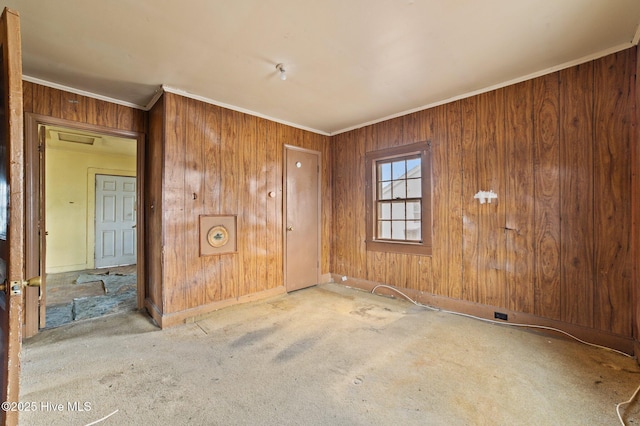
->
[331,274,640,355]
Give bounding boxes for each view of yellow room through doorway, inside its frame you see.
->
[40,125,137,328]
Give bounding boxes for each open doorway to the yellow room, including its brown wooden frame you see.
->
[23,114,145,338]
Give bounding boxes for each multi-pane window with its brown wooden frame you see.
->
[365,142,431,255]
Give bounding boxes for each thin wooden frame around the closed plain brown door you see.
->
[282,144,322,291]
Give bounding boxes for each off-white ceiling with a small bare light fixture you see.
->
[0,0,640,134]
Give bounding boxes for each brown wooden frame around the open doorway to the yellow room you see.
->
[25,113,146,337]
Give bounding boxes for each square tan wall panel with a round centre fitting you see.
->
[200,215,238,256]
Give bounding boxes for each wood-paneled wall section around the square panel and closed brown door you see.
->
[147,93,332,322]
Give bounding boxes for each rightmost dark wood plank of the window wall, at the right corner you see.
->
[593,50,633,334]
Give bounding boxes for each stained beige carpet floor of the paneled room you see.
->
[20,284,640,425]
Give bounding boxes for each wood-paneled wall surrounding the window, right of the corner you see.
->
[331,48,636,337]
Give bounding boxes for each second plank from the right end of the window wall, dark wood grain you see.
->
[560,62,594,327]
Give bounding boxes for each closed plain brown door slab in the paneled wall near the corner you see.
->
[284,146,320,291]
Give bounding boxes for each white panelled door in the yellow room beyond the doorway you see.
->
[95,175,136,268]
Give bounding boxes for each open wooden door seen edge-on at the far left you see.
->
[0,8,25,424]
